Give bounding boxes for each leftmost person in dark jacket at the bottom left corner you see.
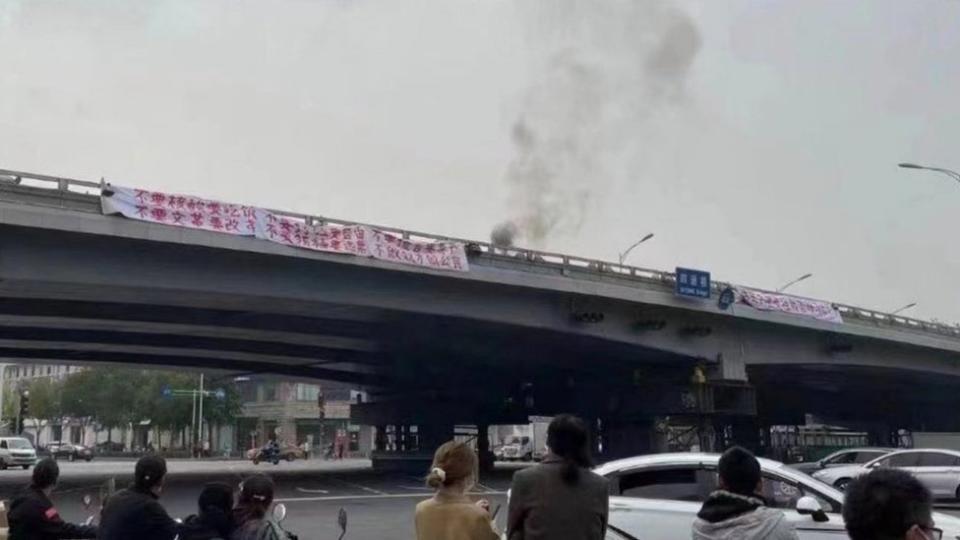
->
[8,458,97,540]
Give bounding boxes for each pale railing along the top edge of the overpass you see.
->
[0,169,960,338]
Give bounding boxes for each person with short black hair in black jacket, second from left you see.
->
[98,455,177,540]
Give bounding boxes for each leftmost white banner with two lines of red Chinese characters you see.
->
[100,186,257,236]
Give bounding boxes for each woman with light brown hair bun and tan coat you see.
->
[414,441,500,540]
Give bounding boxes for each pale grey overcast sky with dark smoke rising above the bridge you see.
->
[0,0,960,321]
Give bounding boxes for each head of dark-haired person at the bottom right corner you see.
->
[843,468,943,540]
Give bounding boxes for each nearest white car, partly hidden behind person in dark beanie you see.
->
[594,453,960,540]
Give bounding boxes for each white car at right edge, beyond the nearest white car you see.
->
[813,449,960,499]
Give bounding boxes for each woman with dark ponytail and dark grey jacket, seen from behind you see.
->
[507,414,610,540]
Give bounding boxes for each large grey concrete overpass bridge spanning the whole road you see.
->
[0,170,960,464]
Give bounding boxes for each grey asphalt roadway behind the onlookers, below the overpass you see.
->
[0,460,512,540]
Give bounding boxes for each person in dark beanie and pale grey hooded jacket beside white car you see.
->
[693,446,799,540]
